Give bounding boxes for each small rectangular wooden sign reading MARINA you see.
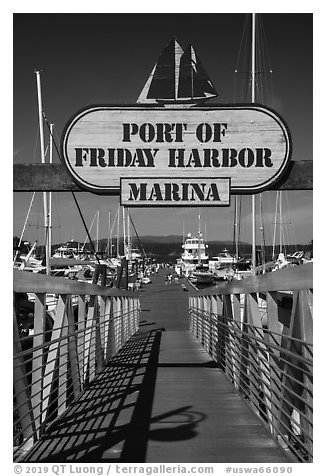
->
[120,177,230,207]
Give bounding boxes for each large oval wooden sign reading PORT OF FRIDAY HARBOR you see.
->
[61,104,291,198]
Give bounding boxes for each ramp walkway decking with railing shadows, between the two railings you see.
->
[25,270,289,463]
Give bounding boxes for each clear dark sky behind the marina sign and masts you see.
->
[13,12,313,244]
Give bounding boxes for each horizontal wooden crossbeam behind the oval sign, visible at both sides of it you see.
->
[13,160,313,190]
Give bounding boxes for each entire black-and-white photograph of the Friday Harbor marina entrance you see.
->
[11,2,314,468]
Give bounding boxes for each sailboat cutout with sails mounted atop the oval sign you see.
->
[137,38,218,104]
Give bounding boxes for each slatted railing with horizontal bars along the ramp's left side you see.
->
[13,271,140,460]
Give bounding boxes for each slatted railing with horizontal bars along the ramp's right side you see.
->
[189,263,313,462]
